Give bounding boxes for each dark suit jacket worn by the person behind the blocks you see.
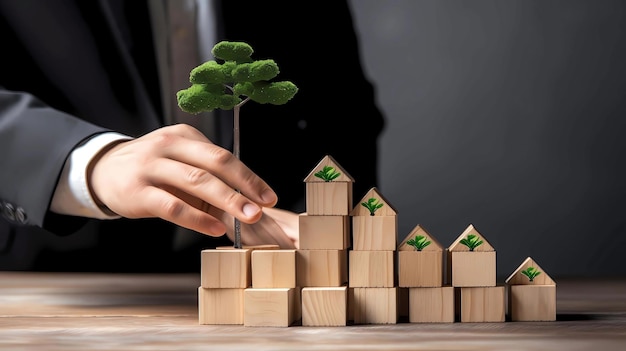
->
[0,0,383,271]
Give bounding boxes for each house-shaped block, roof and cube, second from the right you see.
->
[448,224,496,287]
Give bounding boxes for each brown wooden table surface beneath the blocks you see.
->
[0,272,626,351]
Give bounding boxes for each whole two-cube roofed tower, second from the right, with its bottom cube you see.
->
[448,224,506,322]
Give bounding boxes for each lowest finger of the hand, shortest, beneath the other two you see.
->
[143,186,226,236]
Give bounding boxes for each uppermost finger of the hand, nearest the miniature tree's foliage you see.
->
[152,135,278,207]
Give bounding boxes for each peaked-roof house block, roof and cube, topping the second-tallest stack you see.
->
[350,187,398,251]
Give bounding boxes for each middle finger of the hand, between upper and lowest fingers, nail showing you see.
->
[148,158,262,223]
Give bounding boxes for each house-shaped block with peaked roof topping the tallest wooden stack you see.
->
[304,155,354,216]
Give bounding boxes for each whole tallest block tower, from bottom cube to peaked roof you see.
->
[296,155,354,326]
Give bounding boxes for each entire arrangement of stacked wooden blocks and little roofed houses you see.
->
[198,156,556,327]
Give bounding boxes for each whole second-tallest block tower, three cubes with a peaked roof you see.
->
[348,187,398,324]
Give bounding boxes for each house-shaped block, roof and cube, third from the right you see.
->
[398,224,444,288]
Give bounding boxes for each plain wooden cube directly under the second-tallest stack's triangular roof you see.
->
[352,216,398,251]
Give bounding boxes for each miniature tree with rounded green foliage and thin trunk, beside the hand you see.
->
[176,41,298,248]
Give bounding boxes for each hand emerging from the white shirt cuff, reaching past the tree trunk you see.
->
[87,124,277,236]
